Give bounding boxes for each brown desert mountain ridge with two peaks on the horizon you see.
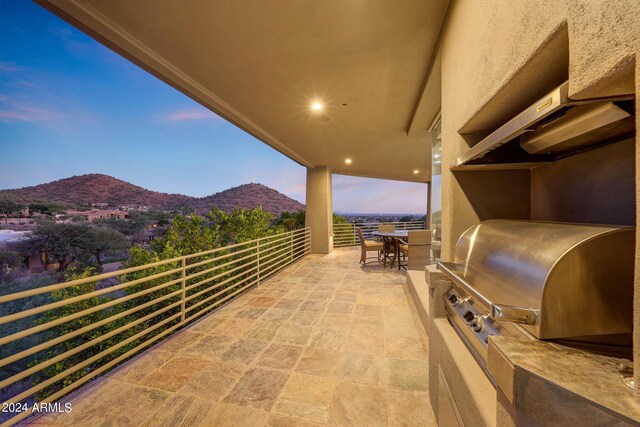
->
[0,174,304,216]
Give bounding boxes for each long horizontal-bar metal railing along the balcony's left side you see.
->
[0,228,311,426]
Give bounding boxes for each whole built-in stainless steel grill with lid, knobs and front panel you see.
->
[438,220,635,378]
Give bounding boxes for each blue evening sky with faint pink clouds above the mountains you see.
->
[0,0,426,213]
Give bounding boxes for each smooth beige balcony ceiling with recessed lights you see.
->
[38,0,448,182]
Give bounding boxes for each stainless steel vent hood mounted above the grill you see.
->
[452,82,635,170]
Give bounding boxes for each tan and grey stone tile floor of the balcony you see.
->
[32,248,435,426]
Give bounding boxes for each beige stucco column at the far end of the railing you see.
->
[306,166,333,254]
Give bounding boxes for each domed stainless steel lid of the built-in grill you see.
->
[444,220,635,339]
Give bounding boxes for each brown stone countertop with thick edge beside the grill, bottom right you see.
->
[489,337,640,424]
